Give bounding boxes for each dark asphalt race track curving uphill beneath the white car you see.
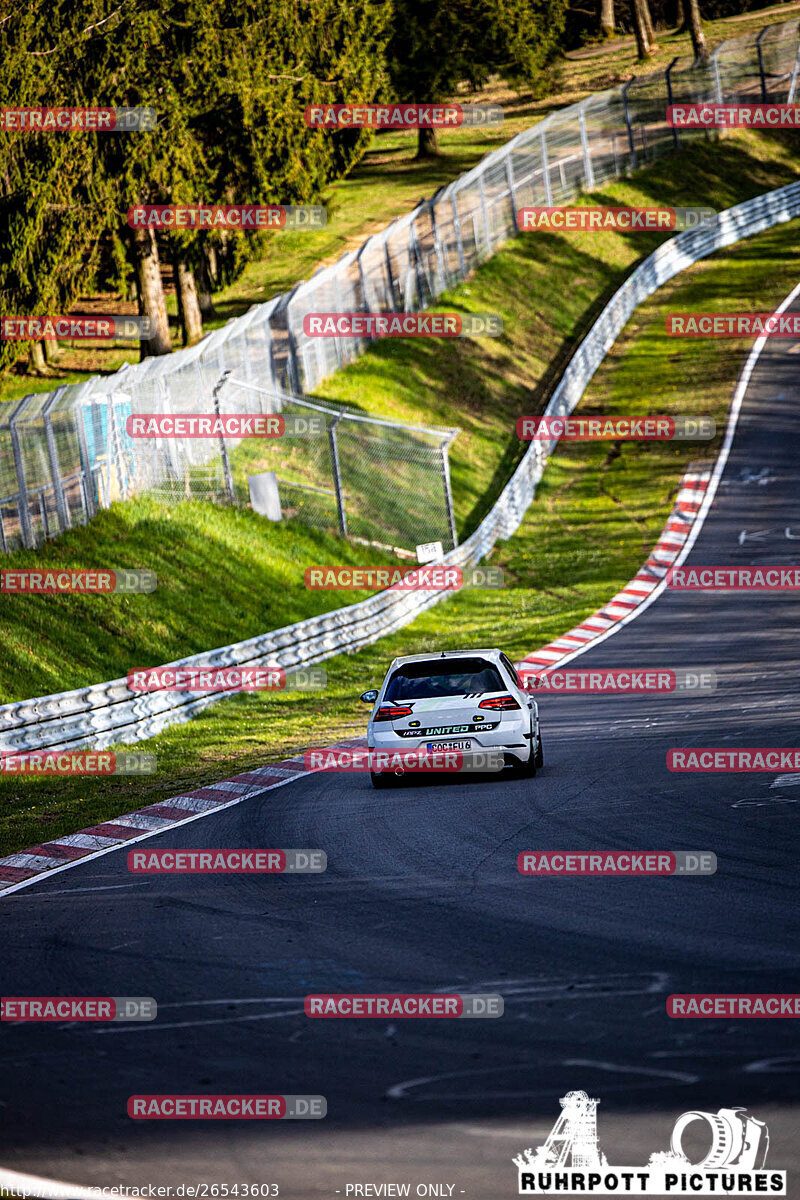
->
[0,314,800,1200]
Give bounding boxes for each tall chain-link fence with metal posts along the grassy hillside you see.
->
[0,18,800,551]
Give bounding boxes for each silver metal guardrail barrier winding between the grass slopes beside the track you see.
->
[0,182,800,751]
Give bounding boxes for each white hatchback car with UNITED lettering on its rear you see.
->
[361,649,545,787]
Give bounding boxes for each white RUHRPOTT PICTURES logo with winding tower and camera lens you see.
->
[513,1092,787,1196]
